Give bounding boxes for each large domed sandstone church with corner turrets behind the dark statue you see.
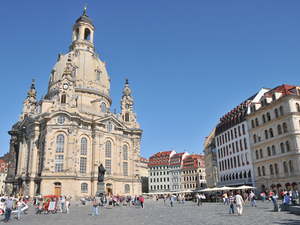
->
[5,5,142,197]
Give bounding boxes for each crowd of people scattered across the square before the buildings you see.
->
[1,189,299,222]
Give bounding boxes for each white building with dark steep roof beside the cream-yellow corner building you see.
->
[215,88,269,186]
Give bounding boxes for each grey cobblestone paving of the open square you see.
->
[0,199,300,225]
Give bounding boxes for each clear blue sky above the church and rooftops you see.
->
[0,0,300,158]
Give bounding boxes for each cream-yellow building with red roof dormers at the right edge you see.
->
[247,84,300,196]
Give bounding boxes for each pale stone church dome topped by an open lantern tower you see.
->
[48,7,110,98]
